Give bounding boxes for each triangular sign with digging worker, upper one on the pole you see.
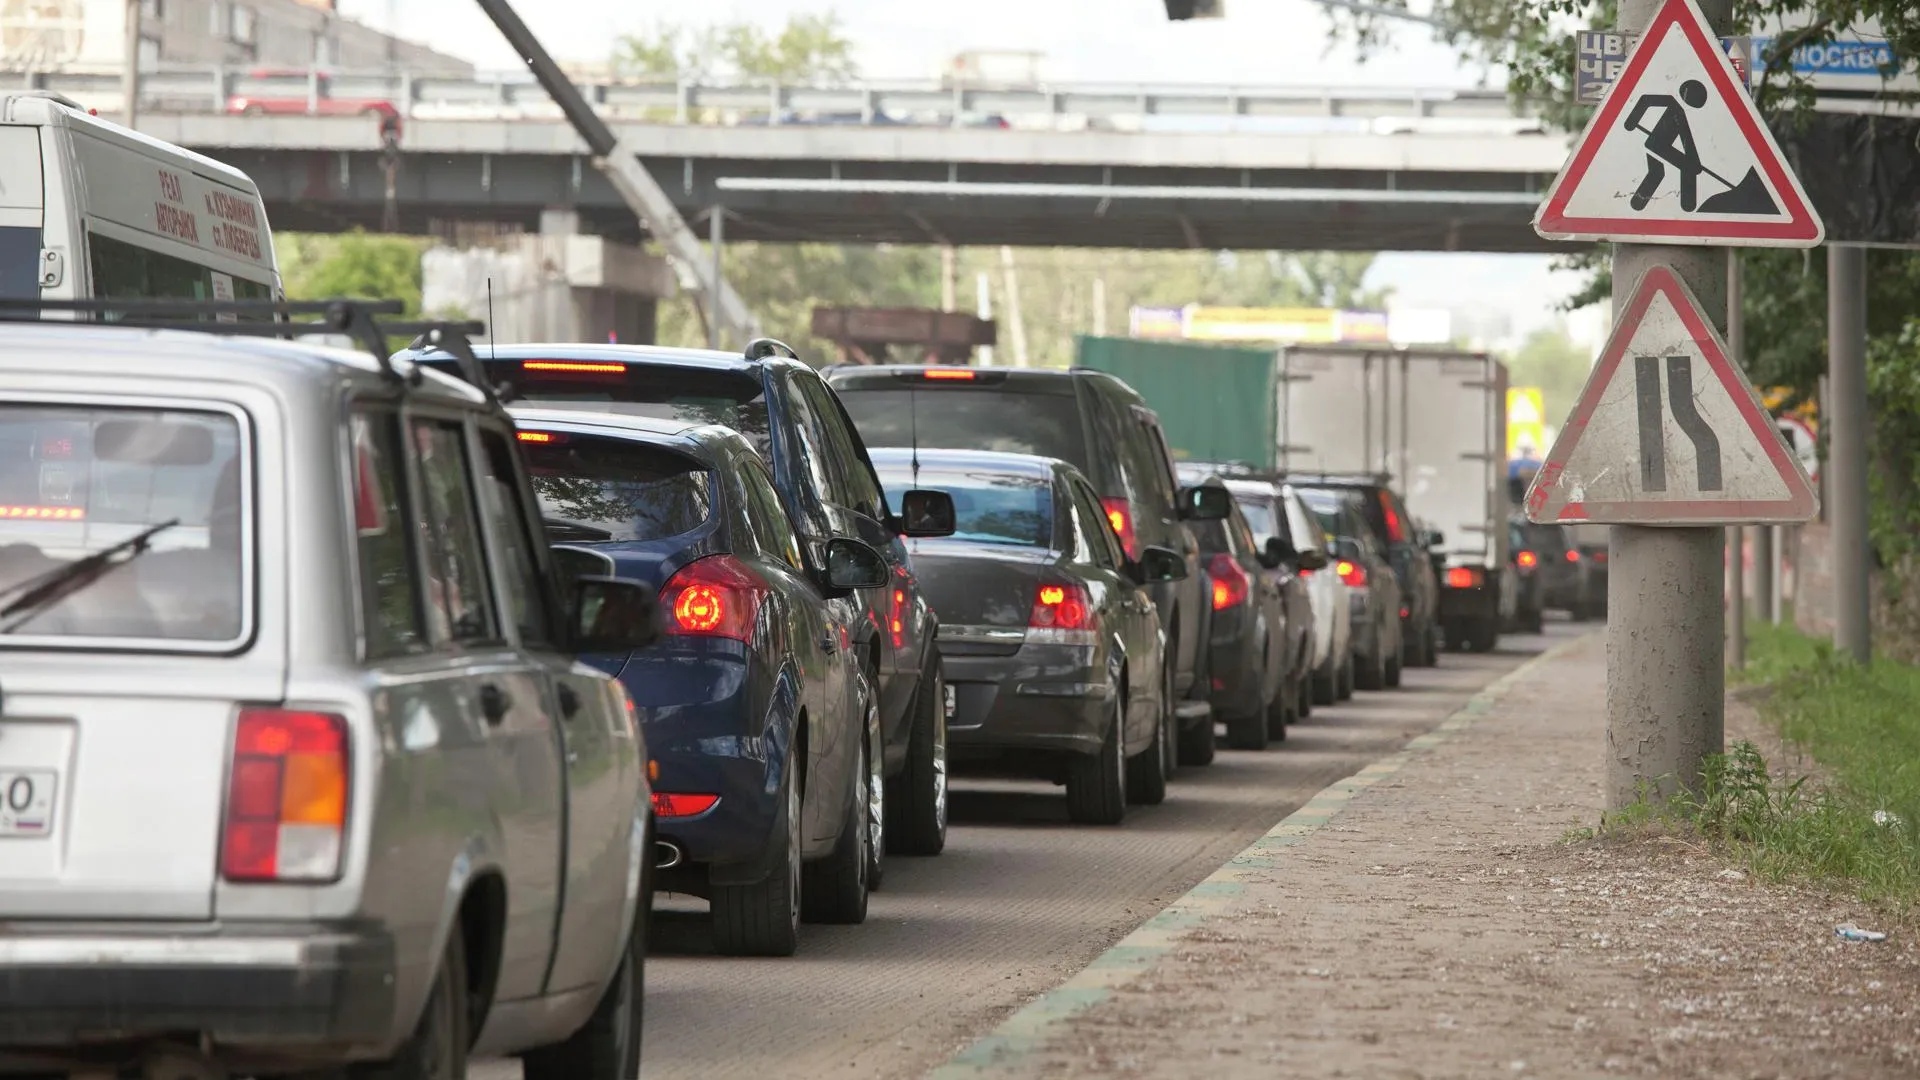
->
[1534,0,1826,248]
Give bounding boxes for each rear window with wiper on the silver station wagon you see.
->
[0,404,250,642]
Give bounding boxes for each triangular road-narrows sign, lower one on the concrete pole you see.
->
[1526,267,1818,525]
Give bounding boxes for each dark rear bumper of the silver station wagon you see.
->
[0,922,397,1067]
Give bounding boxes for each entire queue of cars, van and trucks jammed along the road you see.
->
[0,61,1605,1080]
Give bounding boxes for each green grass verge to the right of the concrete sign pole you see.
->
[1597,623,1920,909]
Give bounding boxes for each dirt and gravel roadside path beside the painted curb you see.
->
[993,634,1920,1080]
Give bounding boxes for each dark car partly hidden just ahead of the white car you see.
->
[1294,484,1405,705]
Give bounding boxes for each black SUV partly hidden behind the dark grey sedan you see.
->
[828,365,1213,765]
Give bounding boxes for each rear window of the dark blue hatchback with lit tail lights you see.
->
[520,430,714,542]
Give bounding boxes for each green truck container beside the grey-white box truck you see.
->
[1075,336,1279,469]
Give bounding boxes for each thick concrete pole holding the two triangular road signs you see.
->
[1607,0,1734,809]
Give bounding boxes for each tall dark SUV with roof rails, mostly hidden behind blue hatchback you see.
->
[405,338,967,855]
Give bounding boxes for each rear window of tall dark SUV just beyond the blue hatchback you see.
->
[474,359,772,459]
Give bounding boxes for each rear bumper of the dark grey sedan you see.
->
[941,644,1114,753]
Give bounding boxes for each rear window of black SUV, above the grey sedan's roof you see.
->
[833,386,1091,473]
